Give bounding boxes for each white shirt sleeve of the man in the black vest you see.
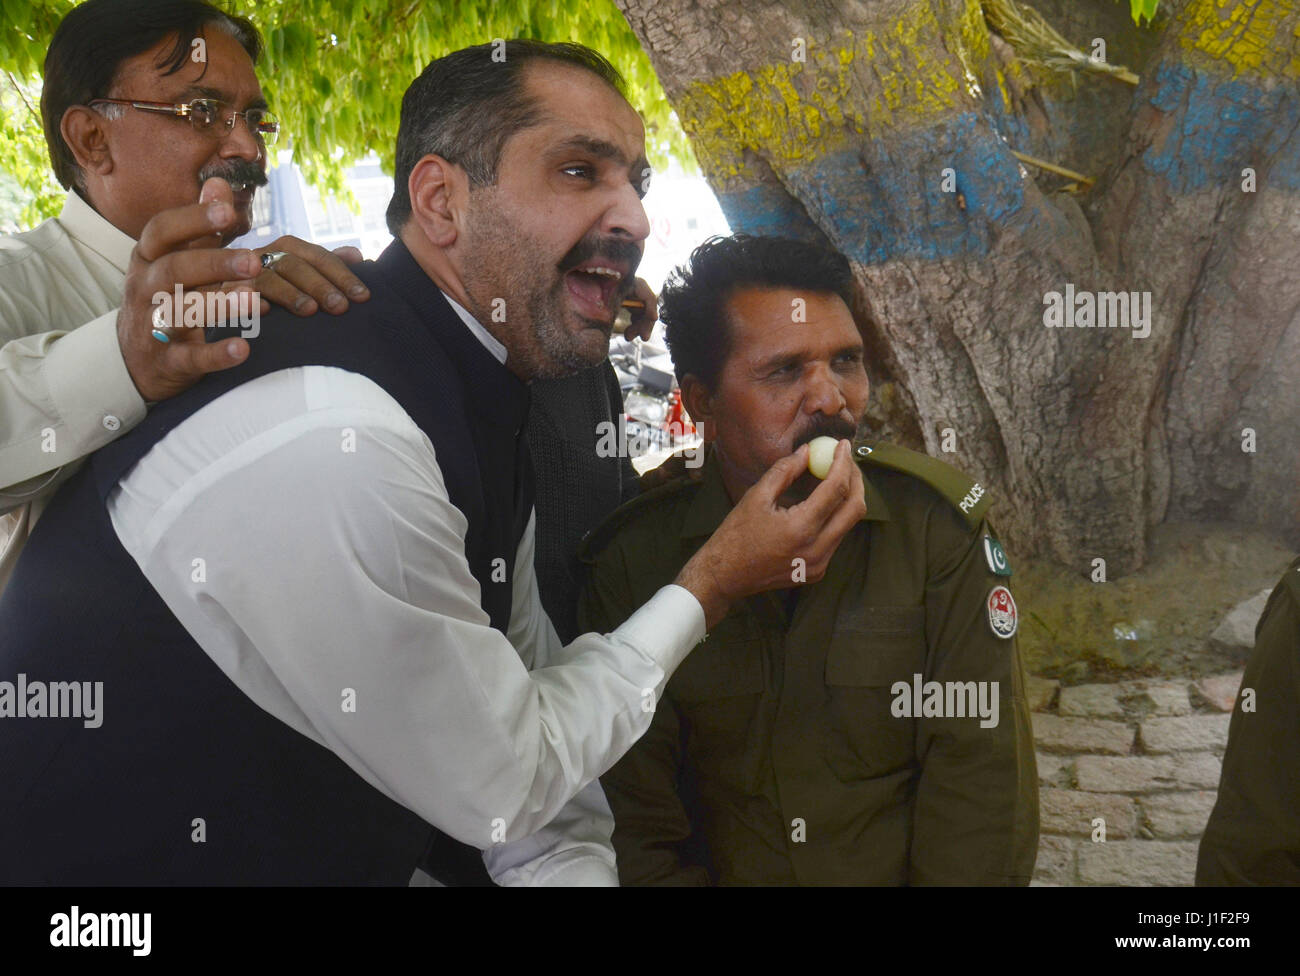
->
[109,368,703,849]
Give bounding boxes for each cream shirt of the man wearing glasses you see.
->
[0,192,144,591]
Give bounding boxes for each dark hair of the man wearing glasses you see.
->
[40,0,261,187]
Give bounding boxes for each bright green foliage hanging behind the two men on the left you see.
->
[0,0,696,224]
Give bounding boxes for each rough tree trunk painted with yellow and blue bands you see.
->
[616,0,1300,576]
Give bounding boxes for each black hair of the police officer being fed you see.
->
[659,234,853,389]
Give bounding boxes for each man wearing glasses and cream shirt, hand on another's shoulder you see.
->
[0,0,368,591]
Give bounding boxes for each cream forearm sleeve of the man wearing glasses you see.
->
[0,309,144,512]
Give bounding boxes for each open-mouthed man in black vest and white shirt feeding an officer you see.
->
[0,40,863,884]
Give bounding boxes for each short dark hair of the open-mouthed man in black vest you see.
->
[387,38,627,237]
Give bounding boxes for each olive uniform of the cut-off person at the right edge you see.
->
[1196,559,1300,885]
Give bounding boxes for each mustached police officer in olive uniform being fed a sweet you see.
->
[581,237,1039,885]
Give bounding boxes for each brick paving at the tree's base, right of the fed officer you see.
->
[1027,672,1242,885]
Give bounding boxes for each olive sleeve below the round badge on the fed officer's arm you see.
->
[910,512,1039,885]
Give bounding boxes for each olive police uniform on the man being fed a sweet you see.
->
[580,443,1039,885]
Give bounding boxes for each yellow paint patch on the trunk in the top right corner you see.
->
[1179,0,1300,79]
